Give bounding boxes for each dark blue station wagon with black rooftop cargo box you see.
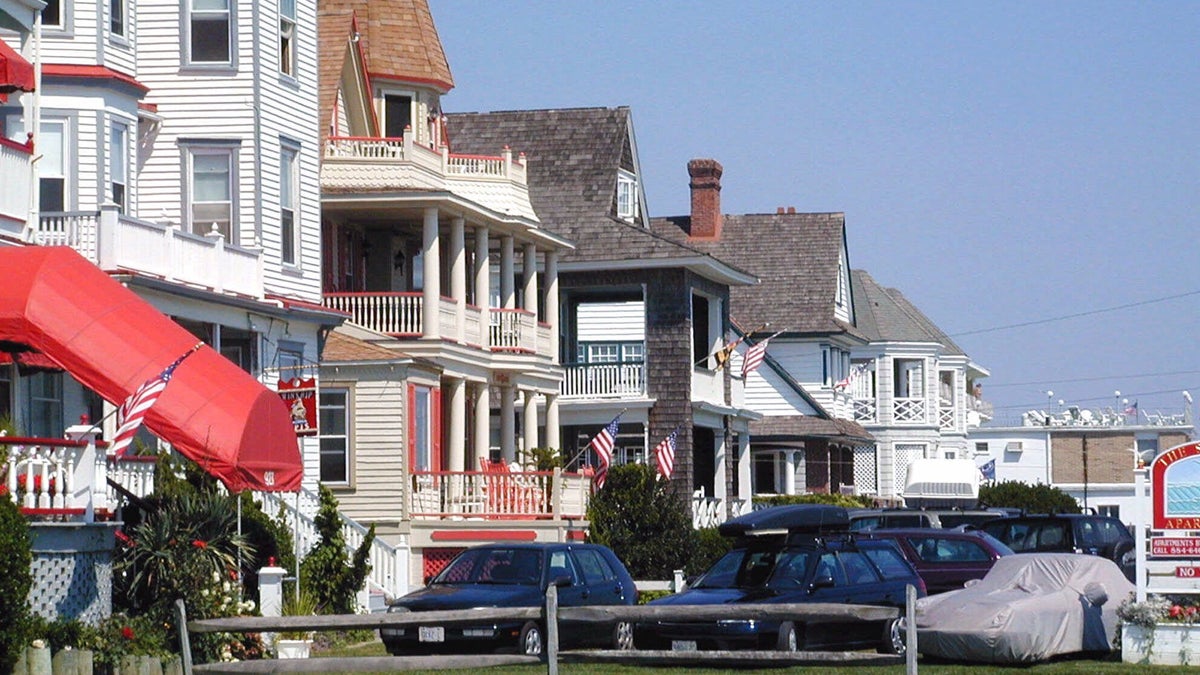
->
[636,506,925,653]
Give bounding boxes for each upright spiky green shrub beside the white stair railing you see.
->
[300,485,374,614]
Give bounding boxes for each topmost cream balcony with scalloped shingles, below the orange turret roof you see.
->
[320,135,538,221]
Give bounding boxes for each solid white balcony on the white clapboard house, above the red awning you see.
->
[34,207,263,298]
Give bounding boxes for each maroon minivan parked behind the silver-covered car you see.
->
[857,527,1013,595]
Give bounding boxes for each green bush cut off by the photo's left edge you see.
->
[0,494,34,673]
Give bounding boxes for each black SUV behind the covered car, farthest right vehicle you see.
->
[980,513,1136,581]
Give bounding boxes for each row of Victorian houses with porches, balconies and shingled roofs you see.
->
[0,0,1180,619]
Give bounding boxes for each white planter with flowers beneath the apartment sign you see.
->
[1117,588,1200,665]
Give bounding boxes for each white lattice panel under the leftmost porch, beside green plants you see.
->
[29,551,113,626]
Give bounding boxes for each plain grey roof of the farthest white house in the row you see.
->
[850,269,965,356]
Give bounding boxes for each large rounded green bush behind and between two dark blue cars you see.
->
[588,464,703,579]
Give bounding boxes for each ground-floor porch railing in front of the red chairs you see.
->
[408,468,592,520]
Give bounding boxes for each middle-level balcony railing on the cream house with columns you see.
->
[325,293,553,357]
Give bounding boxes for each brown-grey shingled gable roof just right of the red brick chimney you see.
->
[650,213,863,339]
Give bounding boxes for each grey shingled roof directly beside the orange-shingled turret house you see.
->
[446,107,754,283]
